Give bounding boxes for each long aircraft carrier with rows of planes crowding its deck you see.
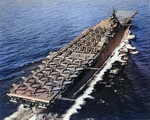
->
[7,10,137,108]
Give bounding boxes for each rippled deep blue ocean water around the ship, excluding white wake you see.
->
[0,0,150,120]
